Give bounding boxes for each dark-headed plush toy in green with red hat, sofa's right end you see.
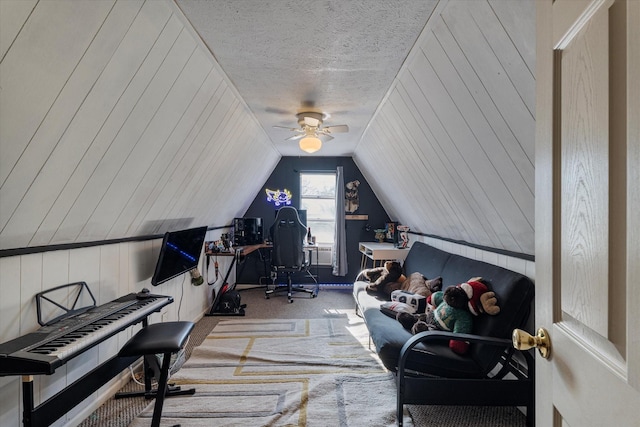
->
[397,277,500,354]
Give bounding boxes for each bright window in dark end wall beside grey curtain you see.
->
[300,172,336,245]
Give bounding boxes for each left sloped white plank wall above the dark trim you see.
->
[0,0,280,249]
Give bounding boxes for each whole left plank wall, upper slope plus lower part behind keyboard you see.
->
[0,0,280,426]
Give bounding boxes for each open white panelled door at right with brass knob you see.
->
[536,0,640,427]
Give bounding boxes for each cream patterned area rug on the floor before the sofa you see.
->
[131,316,413,427]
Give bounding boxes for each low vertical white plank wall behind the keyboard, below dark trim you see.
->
[0,241,215,426]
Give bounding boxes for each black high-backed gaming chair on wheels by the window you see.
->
[265,206,317,302]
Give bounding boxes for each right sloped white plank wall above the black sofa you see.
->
[354,0,535,255]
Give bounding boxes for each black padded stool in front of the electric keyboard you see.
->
[118,322,195,427]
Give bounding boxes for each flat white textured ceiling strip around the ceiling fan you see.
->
[176,0,438,156]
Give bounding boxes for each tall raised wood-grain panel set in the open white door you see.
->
[554,4,609,337]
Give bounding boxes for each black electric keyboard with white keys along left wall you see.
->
[0,293,173,376]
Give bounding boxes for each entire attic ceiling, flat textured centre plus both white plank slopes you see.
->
[0,0,535,254]
